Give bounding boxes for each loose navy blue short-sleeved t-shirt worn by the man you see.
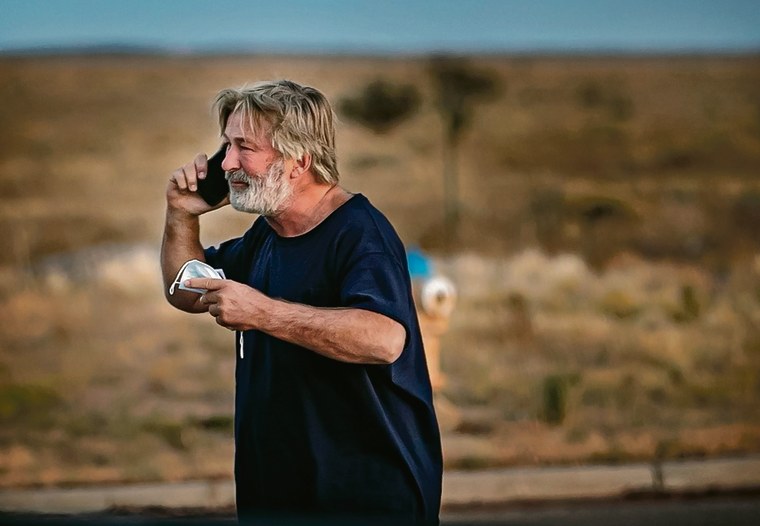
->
[205,194,442,524]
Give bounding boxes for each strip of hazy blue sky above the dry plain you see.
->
[0,0,760,54]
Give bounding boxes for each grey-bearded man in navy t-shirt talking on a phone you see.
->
[161,81,442,524]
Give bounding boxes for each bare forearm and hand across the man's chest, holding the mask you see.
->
[188,278,406,364]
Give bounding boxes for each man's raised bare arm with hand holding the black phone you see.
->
[161,154,229,312]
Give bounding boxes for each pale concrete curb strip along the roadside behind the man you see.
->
[0,455,760,514]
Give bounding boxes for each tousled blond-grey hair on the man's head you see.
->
[214,80,339,184]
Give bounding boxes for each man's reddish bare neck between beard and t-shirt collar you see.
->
[266,184,352,237]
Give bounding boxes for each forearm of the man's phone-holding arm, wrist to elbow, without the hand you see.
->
[161,210,207,312]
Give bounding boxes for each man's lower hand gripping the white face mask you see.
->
[185,278,269,331]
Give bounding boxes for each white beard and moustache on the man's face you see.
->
[226,159,293,216]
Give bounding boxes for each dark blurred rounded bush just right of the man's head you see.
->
[338,80,421,134]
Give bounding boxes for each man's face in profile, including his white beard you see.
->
[222,112,293,216]
